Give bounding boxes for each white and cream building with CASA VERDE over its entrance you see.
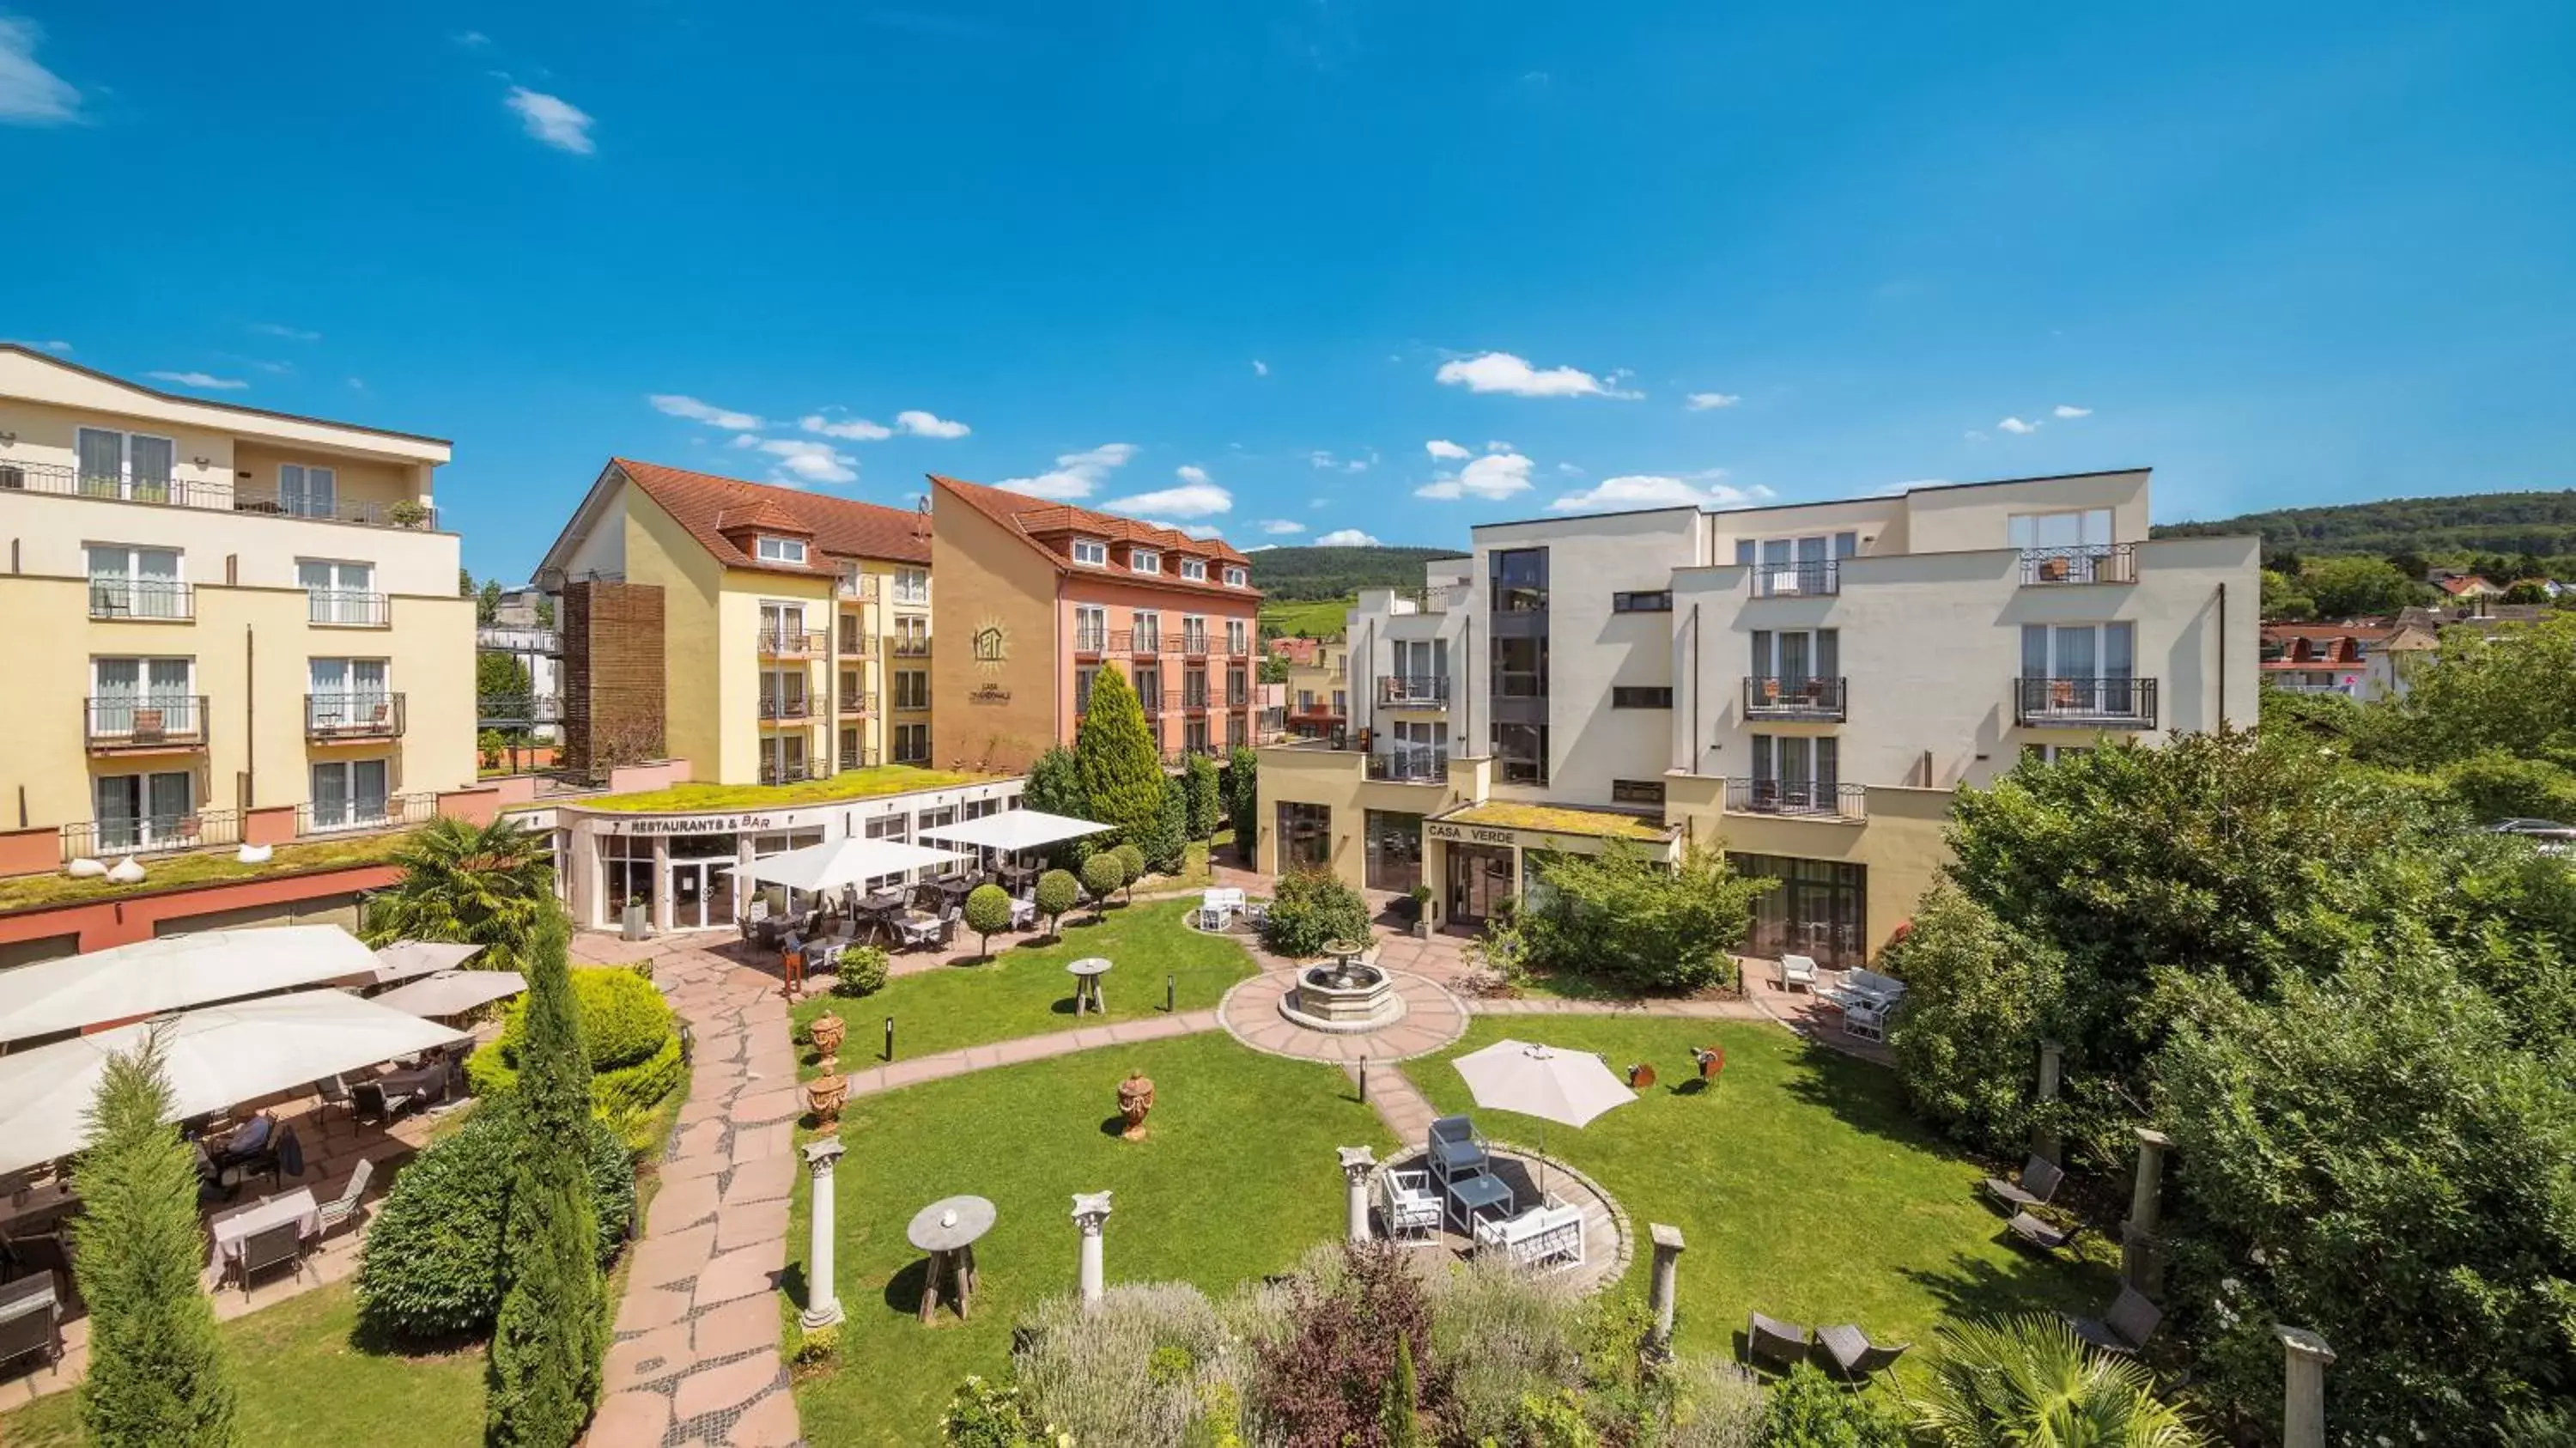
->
[1260,469,2259,964]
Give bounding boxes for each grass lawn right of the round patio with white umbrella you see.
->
[1404,1015,2115,1353]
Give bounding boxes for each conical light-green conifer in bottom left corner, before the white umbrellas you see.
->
[72,1036,242,1448]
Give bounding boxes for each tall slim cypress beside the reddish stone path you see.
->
[484,912,608,1448]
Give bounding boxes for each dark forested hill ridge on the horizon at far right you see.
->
[2154,490,2576,559]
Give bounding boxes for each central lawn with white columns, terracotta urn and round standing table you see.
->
[788,1033,1388,1448]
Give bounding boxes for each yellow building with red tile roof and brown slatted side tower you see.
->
[536,459,930,783]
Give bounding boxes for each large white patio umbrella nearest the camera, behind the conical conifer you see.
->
[0,989,466,1172]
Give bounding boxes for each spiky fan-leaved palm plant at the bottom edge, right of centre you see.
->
[1906,1317,2208,1448]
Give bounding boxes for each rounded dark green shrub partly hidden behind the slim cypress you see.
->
[358,1100,636,1342]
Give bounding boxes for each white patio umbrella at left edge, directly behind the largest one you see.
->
[0,925,379,1041]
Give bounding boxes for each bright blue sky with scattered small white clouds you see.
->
[0,0,2576,577]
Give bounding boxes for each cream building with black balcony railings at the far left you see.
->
[0,345,474,858]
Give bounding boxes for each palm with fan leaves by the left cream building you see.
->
[366,817,556,971]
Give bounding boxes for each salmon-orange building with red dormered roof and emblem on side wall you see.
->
[930,474,1262,770]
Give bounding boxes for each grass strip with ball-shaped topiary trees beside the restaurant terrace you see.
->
[796,899,1252,1056]
